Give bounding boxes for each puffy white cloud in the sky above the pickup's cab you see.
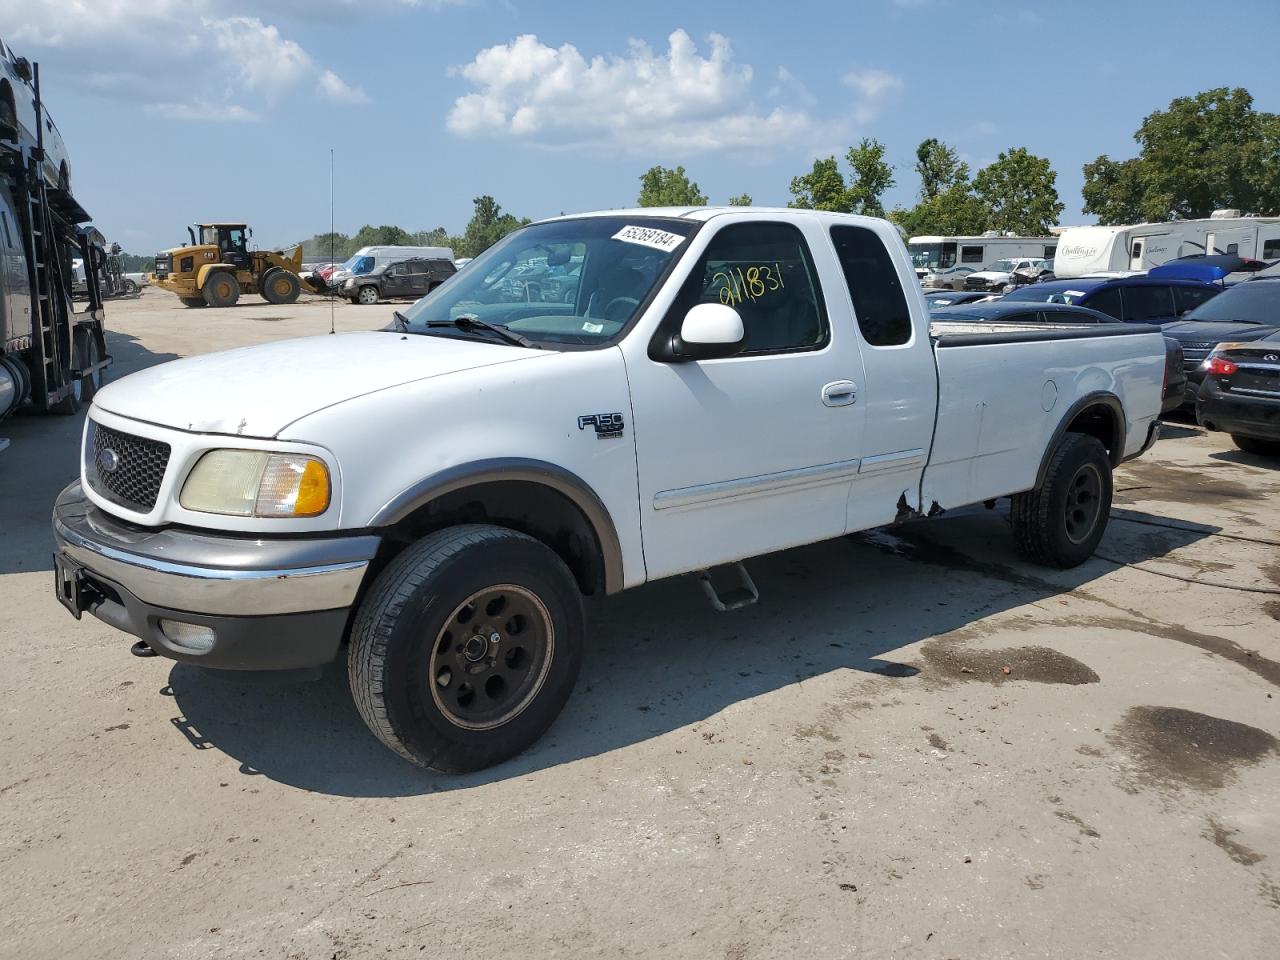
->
[447,29,813,151]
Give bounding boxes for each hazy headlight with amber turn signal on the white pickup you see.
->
[178,451,329,517]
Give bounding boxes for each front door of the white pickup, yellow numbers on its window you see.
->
[622,218,865,579]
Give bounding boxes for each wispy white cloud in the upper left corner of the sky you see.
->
[0,0,373,120]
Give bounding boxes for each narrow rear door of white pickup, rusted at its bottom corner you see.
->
[828,224,938,530]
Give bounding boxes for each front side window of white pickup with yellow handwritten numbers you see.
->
[675,223,831,353]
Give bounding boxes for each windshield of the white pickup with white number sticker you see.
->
[401,216,698,346]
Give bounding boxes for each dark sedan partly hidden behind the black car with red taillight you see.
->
[1165,276,1280,407]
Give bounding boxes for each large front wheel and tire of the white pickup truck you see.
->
[348,525,585,773]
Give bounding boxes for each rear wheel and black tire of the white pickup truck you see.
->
[1011,433,1112,570]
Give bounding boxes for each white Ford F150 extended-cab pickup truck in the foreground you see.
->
[54,207,1165,771]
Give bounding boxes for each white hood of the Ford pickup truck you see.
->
[93,333,554,438]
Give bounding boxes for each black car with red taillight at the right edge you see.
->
[1196,333,1280,456]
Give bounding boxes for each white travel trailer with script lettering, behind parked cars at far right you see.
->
[1053,210,1280,279]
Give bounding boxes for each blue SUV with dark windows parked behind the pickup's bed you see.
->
[1005,276,1224,326]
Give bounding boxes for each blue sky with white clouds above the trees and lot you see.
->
[10,0,1280,253]
